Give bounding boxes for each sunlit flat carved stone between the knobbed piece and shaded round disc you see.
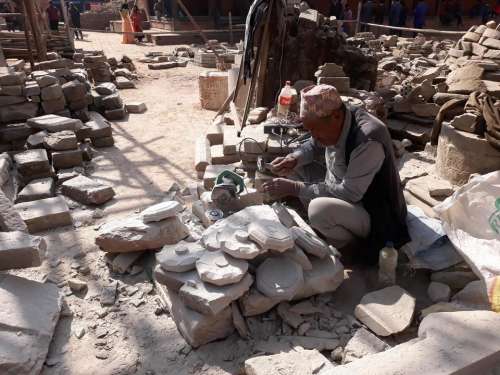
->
[196,251,248,286]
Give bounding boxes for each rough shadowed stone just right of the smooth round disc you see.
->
[294,255,344,299]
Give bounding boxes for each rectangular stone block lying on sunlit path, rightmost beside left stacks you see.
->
[61,175,115,205]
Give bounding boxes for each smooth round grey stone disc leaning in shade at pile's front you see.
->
[256,256,304,301]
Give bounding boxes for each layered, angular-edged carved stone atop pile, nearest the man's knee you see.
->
[248,220,294,252]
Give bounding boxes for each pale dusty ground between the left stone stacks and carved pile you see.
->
[5,33,432,375]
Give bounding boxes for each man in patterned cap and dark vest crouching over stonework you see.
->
[263,85,409,262]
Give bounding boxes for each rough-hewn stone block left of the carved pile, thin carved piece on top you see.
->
[94,214,189,253]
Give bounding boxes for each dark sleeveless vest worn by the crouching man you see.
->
[346,109,410,263]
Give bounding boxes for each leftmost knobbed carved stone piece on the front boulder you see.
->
[156,241,206,272]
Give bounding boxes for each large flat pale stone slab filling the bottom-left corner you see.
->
[0,275,62,374]
